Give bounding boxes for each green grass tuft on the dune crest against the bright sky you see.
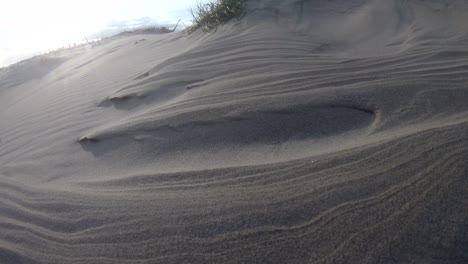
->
[187,0,244,32]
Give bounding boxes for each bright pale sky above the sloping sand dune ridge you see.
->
[0,0,197,67]
